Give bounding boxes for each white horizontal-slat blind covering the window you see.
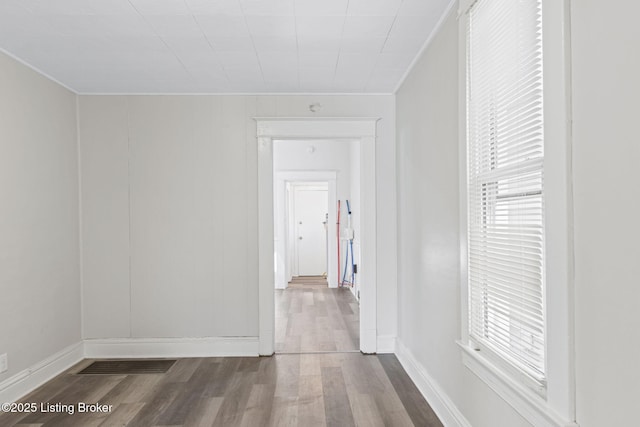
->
[467,0,546,390]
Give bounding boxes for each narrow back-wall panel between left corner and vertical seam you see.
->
[79,97,131,338]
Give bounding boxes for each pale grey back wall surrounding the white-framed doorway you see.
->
[79,96,396,338]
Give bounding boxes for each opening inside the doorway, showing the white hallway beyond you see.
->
[273,139,360,353]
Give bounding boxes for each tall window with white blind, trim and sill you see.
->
[459,0,576,427]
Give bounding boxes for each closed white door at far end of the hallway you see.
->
[293,188,328,276]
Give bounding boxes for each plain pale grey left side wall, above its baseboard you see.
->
[0,53,81,382]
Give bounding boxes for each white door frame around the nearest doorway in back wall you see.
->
[254,117,379,356]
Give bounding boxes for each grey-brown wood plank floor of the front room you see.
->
[0,353,442,427]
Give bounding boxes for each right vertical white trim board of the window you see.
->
[542,0,576,420]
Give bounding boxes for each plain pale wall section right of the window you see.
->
[572,0,640,427]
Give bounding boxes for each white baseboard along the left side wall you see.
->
[0,342,84,403]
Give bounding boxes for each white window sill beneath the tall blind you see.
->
[458,341,578,427]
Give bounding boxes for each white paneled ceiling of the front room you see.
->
[0,0,451,93]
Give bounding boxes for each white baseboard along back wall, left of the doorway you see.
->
[84,337,258,359]
